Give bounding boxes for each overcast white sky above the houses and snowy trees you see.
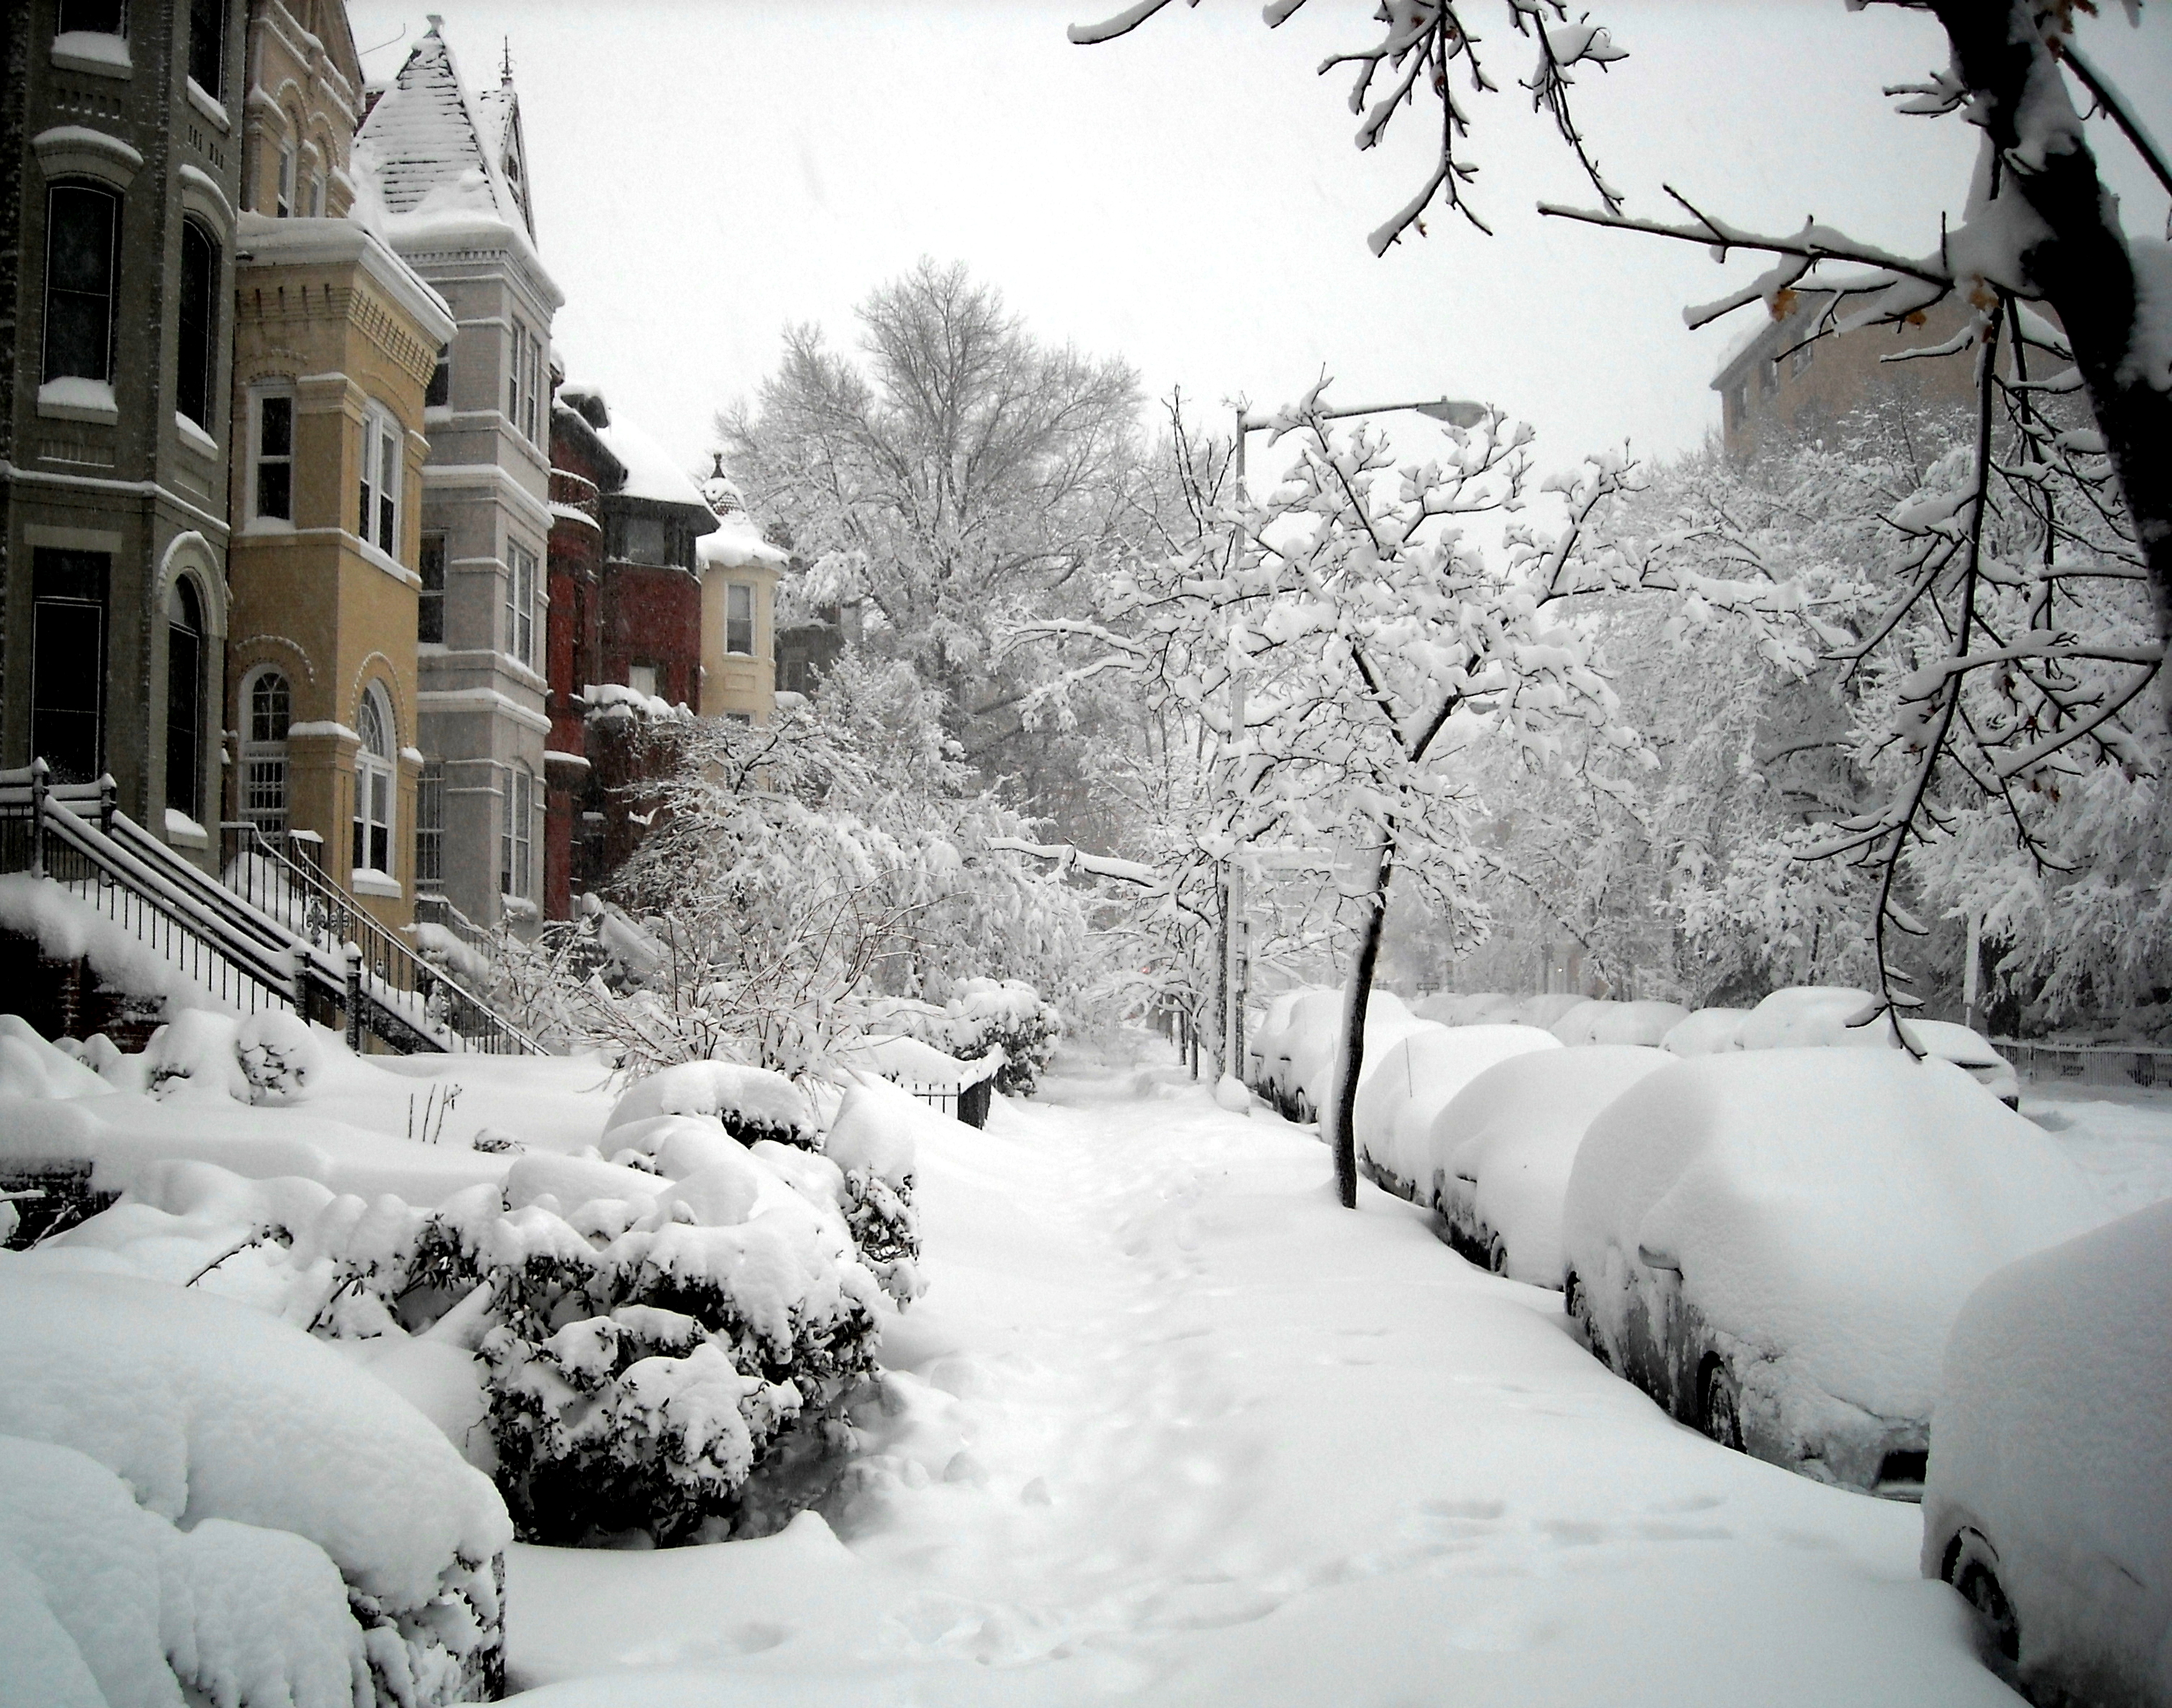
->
[348,0,2172,478]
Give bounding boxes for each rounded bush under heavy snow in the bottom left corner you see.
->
[0,1251,512,1708]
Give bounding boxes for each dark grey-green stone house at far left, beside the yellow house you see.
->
[0,0,246,863]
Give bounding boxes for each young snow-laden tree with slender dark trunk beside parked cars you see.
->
[1038,391,1801,1204]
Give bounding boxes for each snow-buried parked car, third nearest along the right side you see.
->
[1431,1043,1675,1287]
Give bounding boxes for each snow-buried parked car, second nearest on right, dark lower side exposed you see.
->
[1561,1050,2105,1495]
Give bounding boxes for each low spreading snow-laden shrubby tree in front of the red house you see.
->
[534,650,1084,1074]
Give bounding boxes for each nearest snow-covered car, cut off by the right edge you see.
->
[1922,1202,2172,1708]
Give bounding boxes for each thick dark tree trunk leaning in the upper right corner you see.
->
[1933,0,2172,704]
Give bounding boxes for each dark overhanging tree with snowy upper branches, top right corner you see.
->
[1071,0,2172,678]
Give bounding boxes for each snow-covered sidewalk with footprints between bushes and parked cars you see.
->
[508,1051,2016,1708]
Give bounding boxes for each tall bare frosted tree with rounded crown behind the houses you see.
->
[717,261,1140,776]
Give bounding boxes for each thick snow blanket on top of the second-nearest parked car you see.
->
[1561,1050,2107,1417]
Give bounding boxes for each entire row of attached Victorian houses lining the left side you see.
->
[0,0,786,1012]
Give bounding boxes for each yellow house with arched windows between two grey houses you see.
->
[226,0,454,928]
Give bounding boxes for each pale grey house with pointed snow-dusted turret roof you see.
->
[354,17,563,926]
